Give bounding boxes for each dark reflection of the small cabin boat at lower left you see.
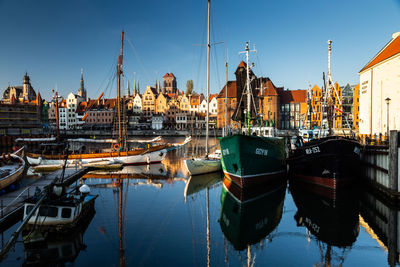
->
[22,210,95,266]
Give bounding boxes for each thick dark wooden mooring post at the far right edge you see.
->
[389,130,399,193]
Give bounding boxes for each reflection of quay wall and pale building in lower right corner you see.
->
[360,190,400,266]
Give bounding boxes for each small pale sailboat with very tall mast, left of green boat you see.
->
[185,0,221,175]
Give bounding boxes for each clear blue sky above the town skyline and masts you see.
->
[0,0,400,100]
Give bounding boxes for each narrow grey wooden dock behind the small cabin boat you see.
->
[0,167,91,230]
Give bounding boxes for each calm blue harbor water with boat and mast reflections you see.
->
[1,139,398,266]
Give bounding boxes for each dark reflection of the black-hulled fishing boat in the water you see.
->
[289,181,359,266]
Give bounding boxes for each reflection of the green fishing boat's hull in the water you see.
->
[219,178,286,250]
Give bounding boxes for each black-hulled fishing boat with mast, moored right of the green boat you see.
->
[288,41,361,190]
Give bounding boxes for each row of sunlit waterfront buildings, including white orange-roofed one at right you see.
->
[0,33,400,136]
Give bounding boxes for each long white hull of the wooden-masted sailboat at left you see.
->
[26,149,168,166]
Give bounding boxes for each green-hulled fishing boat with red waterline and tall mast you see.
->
[220,43,286,188]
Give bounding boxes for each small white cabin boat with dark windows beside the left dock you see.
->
[24,185,98,232]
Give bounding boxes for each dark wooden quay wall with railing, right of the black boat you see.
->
[361,130,400,199]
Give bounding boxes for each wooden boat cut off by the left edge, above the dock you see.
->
[0,154,25,190]
